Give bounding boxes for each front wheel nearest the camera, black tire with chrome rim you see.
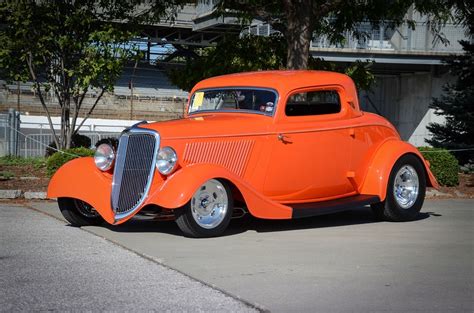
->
[175,179,234,238]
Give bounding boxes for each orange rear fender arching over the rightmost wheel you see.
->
[359,140,439,201]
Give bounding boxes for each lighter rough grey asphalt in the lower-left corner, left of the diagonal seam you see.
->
[0,203,256,312]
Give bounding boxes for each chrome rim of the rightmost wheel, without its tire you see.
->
[393,165,420,209]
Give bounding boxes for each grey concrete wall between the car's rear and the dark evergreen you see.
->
[361,72,452,146]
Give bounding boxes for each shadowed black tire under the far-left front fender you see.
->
[58,198,104,227]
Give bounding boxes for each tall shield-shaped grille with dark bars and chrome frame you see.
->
[112,129,159,220]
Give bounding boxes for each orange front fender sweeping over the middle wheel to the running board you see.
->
[147,164,292,219]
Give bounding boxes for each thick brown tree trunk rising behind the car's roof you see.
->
[284,0,313,70]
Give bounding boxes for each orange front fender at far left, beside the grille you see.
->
[48,157,114,224]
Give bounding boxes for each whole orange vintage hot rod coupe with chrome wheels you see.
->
[48,71,438,237]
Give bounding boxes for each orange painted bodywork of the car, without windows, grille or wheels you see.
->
[48,71,438,223]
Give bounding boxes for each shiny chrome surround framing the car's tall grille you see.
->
[110,126,160,224]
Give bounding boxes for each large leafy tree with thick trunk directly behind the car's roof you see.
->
[169,0,452,90]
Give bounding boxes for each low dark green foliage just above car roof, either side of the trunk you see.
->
[168,34,375,91]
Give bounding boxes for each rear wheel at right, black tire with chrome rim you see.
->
[372,154,426,222]
